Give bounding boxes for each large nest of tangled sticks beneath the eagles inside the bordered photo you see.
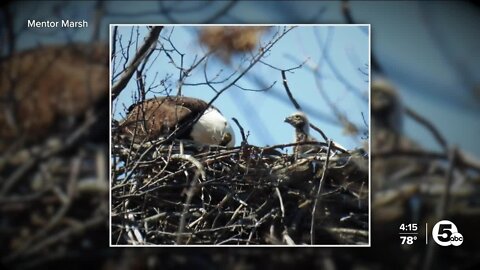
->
[111,141,369,245]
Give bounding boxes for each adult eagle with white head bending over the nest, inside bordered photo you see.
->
[120,96,234,146]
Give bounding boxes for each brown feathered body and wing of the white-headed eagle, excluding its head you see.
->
[120,97,208,142]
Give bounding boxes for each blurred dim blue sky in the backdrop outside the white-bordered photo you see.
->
[4,1,480,155]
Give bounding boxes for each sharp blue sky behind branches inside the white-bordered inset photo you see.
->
[113,26,369,151]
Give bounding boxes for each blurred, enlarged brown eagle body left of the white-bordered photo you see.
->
[0,43,109,148]
